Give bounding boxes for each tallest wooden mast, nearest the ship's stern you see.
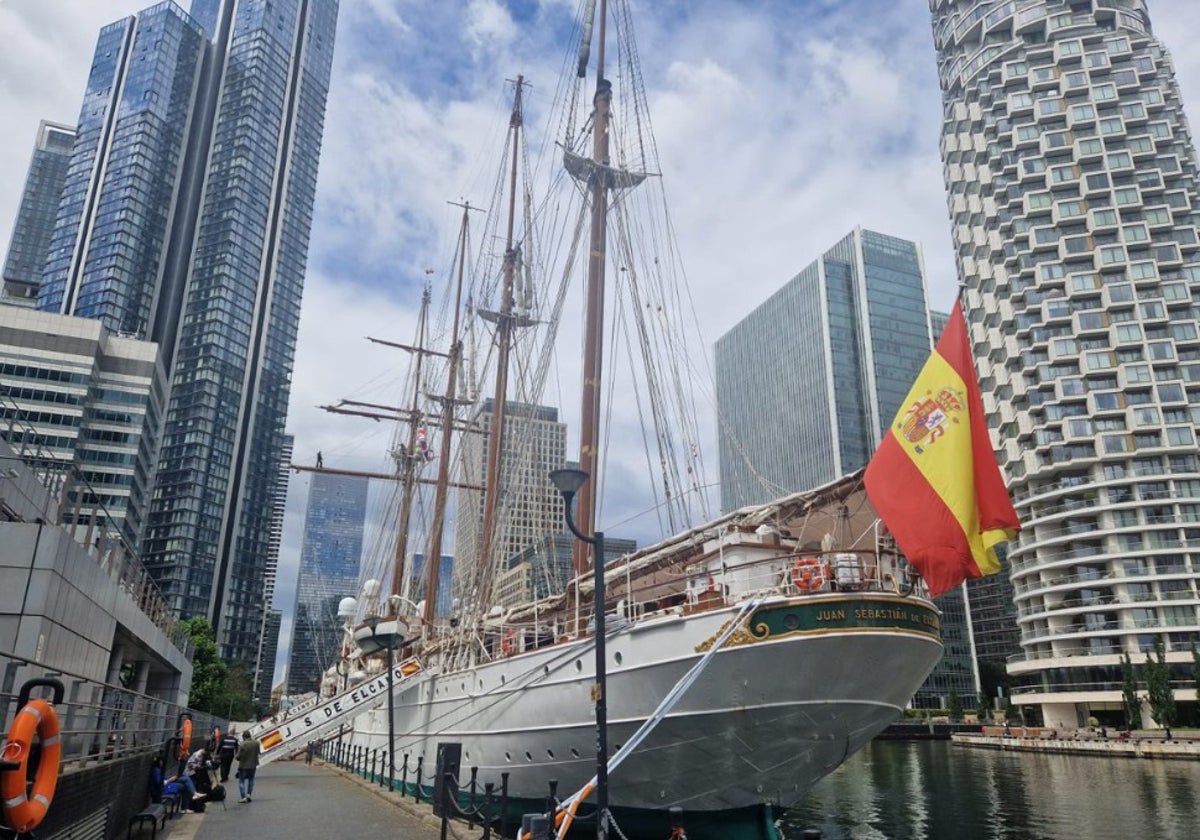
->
[575,0,612,578]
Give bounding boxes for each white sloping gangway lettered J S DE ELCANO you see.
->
[246,656,425,764]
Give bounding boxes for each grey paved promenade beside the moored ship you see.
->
[154,761,463,840]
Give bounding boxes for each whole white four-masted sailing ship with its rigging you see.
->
[256,0,942,840]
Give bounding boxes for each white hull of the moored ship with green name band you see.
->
[352,593,942,828]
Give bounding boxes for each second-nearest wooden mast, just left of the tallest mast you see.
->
[479,76,524,596]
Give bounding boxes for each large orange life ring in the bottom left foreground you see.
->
[0,700,62,834]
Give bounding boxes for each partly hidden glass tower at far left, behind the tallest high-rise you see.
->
[0,120,74,306]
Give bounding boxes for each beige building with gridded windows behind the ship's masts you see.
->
[454,400,566,600]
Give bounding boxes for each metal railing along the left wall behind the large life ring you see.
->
[0,653,227,774]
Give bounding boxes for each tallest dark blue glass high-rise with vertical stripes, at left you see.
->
[24,0,338,661]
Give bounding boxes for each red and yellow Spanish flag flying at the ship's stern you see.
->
[865,304,1021,598]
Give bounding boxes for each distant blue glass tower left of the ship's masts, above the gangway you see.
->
[288,473,368,692]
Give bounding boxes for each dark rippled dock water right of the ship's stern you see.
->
[781,742,1200,840]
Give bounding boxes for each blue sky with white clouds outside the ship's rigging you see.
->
[0,0,1200,681]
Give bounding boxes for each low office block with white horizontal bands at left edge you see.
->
[0,306,166,554]
